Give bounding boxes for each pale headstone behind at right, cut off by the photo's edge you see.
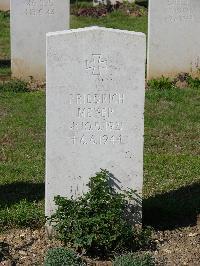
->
[147,0,200,79]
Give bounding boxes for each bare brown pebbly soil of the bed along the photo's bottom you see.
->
[0,217,200,266]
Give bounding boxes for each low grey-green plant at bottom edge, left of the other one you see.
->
[44,248,86,266]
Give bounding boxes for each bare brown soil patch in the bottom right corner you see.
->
[153,219,200,266]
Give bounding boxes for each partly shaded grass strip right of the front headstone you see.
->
[144,83,200,228]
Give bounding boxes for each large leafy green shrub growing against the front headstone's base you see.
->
[49,170,150,255]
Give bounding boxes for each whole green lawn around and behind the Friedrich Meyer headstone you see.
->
[0,7,200,229]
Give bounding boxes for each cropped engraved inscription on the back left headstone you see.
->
[25,0,55,16]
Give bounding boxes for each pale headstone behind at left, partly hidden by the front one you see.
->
[11,0,69,81]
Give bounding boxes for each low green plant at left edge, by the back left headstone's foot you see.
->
[0,79,29,92]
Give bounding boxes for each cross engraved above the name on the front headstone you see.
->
[86,54,107,76]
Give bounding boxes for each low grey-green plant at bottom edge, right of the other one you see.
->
[113,253,155,266]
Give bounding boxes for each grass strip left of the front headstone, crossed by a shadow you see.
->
[0,89,45,228]
